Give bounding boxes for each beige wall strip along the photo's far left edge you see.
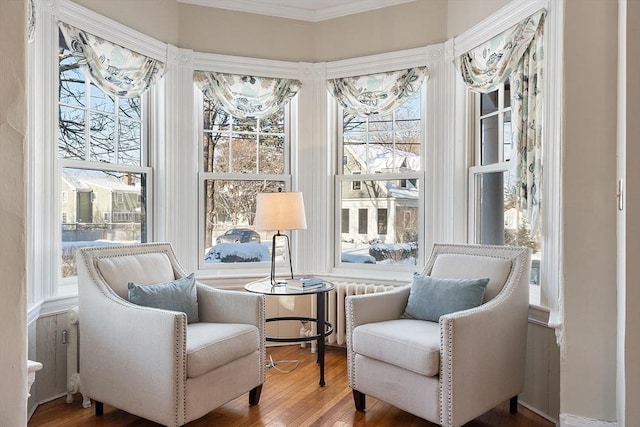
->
[0,0,27,427]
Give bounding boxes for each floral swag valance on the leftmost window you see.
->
[58,22,165,98]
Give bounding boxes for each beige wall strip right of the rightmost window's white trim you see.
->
[560,0,620,421]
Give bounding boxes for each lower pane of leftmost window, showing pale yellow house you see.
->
[60,168,147,277]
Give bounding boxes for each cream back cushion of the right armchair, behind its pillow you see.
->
[430,254,512,303]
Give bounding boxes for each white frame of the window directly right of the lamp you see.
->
[326,44,444,284]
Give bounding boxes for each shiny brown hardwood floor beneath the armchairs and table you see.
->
[28,345,554,427]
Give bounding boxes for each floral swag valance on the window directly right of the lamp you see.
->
[327,67,427,117]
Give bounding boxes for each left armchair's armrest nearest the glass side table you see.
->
[197,283,265,331]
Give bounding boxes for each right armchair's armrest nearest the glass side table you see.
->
[345,285,411,335]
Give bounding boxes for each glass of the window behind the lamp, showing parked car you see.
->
[198,95,291,267]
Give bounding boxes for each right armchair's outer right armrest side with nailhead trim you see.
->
[440,287,528,425]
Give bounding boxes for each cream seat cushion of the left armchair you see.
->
[187,322,260,378]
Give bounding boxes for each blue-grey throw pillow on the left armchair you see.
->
[129,273,199,323]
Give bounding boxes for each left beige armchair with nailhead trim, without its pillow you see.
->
[76,243,265,426]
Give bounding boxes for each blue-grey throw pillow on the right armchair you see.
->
[402,275,489,322]
